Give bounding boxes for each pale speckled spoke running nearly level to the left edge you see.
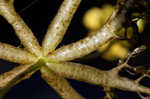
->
[0,43,37,64]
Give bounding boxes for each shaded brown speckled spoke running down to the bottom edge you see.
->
[41,67,84,99]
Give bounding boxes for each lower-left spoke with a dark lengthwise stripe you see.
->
[0,64,37,93]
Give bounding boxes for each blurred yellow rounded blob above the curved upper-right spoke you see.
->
[83,5,113,31]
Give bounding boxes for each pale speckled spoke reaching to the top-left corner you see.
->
[0,0,42,56]
